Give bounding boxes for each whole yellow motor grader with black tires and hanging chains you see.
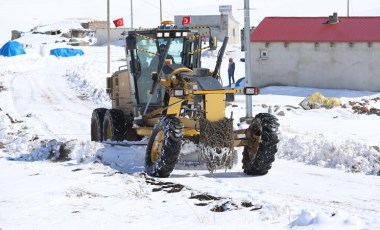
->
[91,21,279,177]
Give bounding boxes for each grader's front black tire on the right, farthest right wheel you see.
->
[242,113,280,176]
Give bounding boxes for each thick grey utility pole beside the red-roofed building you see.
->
[244,0,253,118]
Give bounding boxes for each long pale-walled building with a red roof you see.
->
[250,13,380,91]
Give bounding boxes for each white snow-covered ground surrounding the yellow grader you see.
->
[0,20,380,230]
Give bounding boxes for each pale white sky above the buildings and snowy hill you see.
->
[0,0,380,44]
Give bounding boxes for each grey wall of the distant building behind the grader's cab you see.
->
[174,15,240,44]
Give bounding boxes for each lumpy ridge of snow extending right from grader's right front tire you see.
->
[277,135,380,175]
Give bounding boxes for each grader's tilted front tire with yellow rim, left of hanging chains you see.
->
[145,116,183,177]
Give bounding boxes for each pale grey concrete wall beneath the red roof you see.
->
[251,42,380,91]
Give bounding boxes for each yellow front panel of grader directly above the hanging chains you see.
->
[205,94,226,121]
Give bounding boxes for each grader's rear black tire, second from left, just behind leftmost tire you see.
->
[103,109,126,141]
